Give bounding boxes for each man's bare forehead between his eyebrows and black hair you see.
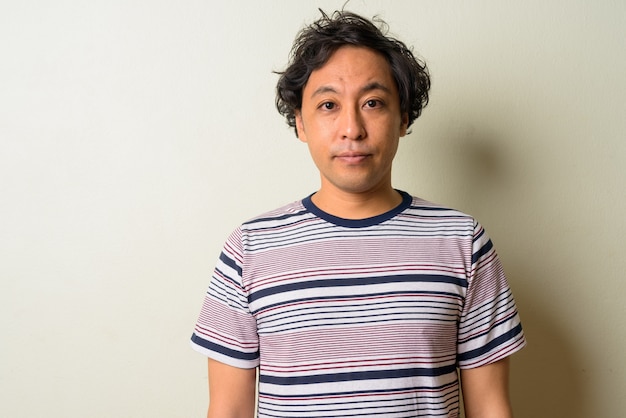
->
[304,46,396,95]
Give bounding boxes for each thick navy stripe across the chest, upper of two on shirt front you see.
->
[249,274,467,302]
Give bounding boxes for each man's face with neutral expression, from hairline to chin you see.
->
[296,46,408,198]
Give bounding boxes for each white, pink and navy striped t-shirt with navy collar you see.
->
[192,192,525,418]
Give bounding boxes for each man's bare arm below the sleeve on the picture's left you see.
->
[207,359,256,418]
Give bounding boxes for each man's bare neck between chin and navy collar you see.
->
[311,186,402,219]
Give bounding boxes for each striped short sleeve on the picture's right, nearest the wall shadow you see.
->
[457,222,526,368]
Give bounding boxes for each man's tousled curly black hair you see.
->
[276,10,430,135]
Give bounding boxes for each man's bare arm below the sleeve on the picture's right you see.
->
[461,357,513,418]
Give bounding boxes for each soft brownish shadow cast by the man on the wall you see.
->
[416,125,594,418]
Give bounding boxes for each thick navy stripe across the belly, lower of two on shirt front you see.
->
[259,364,456,386]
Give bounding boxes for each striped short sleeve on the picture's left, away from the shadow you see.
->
[191,229,259,368]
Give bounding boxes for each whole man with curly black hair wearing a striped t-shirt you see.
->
[192,12,525,418]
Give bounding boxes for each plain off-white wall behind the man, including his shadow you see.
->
[0,0,626,418]
